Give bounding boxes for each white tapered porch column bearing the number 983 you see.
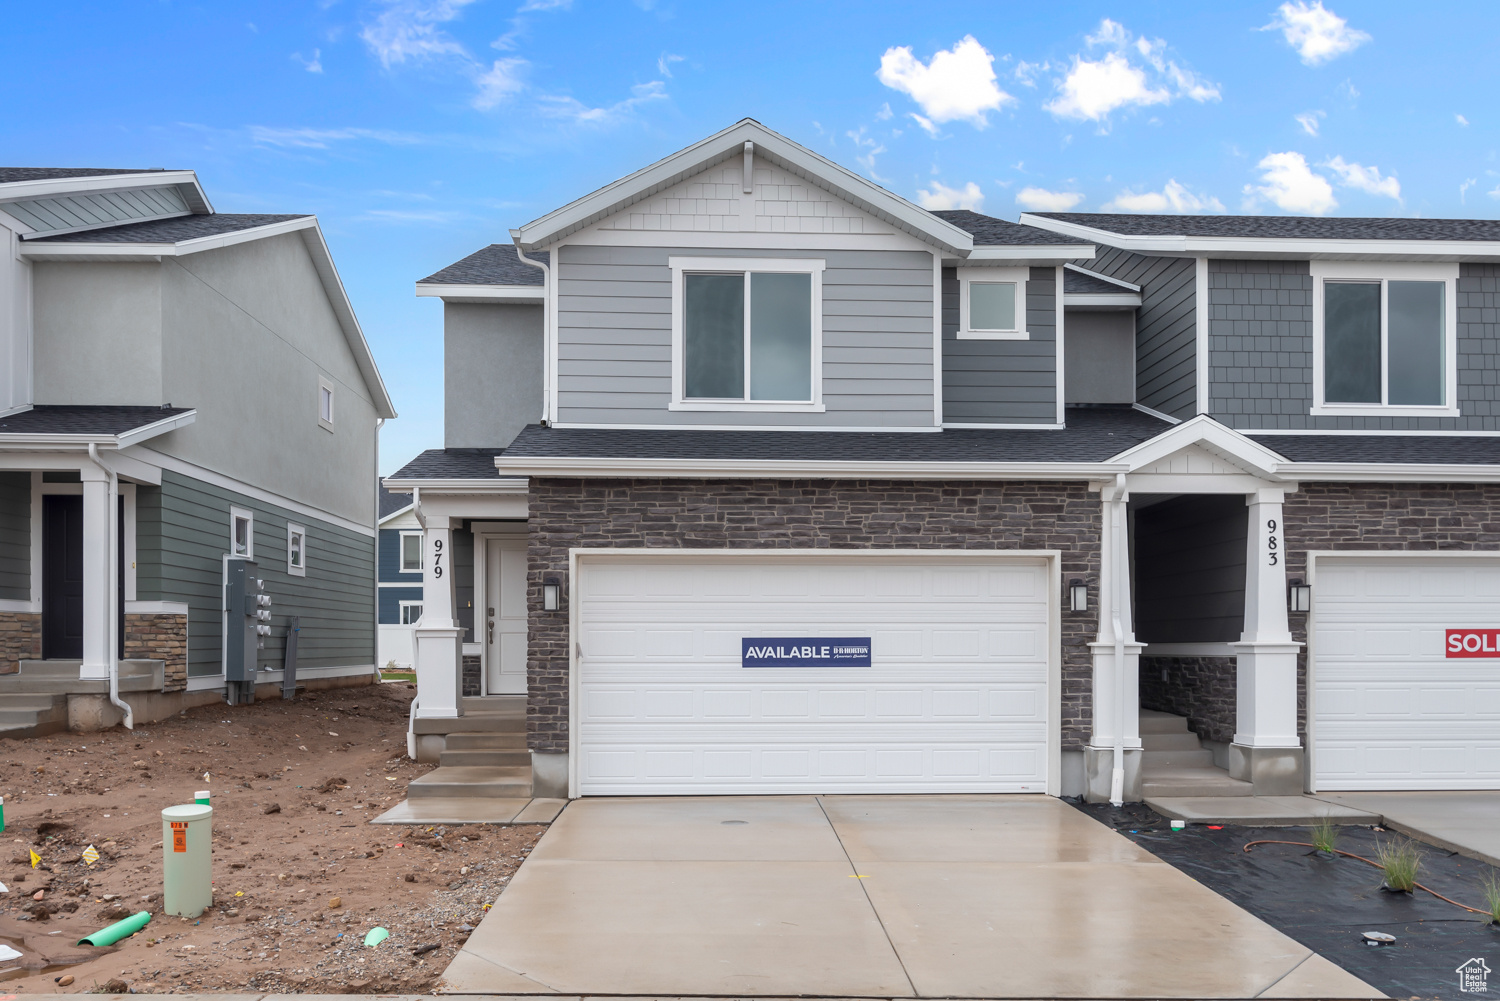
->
[1230,488,1304,795]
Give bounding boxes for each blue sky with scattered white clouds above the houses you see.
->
[0,0,1500,473]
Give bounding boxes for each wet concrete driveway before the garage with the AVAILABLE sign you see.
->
[444,795,1383,998]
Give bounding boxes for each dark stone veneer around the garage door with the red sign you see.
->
[1283,483,1500,737]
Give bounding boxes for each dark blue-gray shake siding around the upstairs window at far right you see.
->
[1209,261,1500,431]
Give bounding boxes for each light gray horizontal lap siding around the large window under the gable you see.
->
[557,246,933,428]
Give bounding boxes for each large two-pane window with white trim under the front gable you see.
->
[671,258,824,411]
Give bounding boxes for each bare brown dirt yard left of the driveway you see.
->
[0,684,546,993]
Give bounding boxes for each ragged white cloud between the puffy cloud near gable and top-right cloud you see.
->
[1043,18,1221,125]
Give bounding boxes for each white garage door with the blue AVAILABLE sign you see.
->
[575,554,1056,795]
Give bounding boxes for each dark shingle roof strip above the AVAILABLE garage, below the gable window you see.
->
[504,407,1172,462]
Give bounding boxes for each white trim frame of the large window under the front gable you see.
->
[668,257,828,414]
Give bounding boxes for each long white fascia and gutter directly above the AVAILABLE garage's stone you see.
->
[495,456,1130,480]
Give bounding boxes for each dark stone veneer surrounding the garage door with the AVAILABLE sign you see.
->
[527,477,1100,752]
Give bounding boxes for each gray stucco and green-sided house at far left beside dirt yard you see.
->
[0,168,395,734]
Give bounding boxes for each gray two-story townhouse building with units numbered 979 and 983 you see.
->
[387,120,1500,800]
